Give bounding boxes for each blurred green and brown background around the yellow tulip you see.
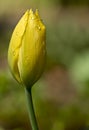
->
[0,0,89,130]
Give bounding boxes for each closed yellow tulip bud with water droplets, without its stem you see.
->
[8,10,46,87]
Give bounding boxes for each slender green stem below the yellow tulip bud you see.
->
[25,87,39,130]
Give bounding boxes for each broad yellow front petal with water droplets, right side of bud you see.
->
[18,11,46,86]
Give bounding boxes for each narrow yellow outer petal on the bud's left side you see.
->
[8,10,29,82]
